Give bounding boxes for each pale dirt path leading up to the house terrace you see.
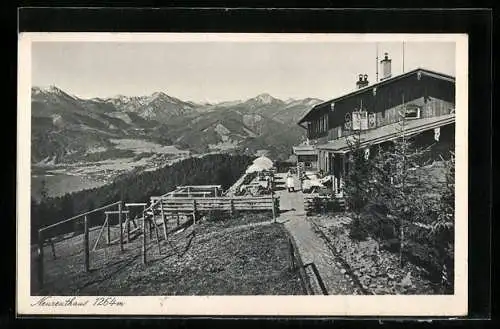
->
[276,174,358,295]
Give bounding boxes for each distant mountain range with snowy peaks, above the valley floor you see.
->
[31,86,321,163]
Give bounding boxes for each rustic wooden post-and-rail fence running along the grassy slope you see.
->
[36,185,279,289]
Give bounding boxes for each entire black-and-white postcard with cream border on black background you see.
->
[18,33,468,315]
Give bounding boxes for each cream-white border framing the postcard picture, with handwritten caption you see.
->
[16,33,468,316]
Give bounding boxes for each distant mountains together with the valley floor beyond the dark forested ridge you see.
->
[31,86,321,200]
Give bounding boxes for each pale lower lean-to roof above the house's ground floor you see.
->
[317,113,455,153]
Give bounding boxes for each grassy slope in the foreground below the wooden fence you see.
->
[32,215,302,295]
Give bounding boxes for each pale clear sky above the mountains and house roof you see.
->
[32,41,455,103]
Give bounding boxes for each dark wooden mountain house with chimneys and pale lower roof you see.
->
[298,54,455,195]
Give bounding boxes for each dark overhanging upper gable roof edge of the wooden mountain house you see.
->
[298,68,455,125]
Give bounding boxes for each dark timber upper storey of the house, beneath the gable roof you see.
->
[299,69,455,144]
